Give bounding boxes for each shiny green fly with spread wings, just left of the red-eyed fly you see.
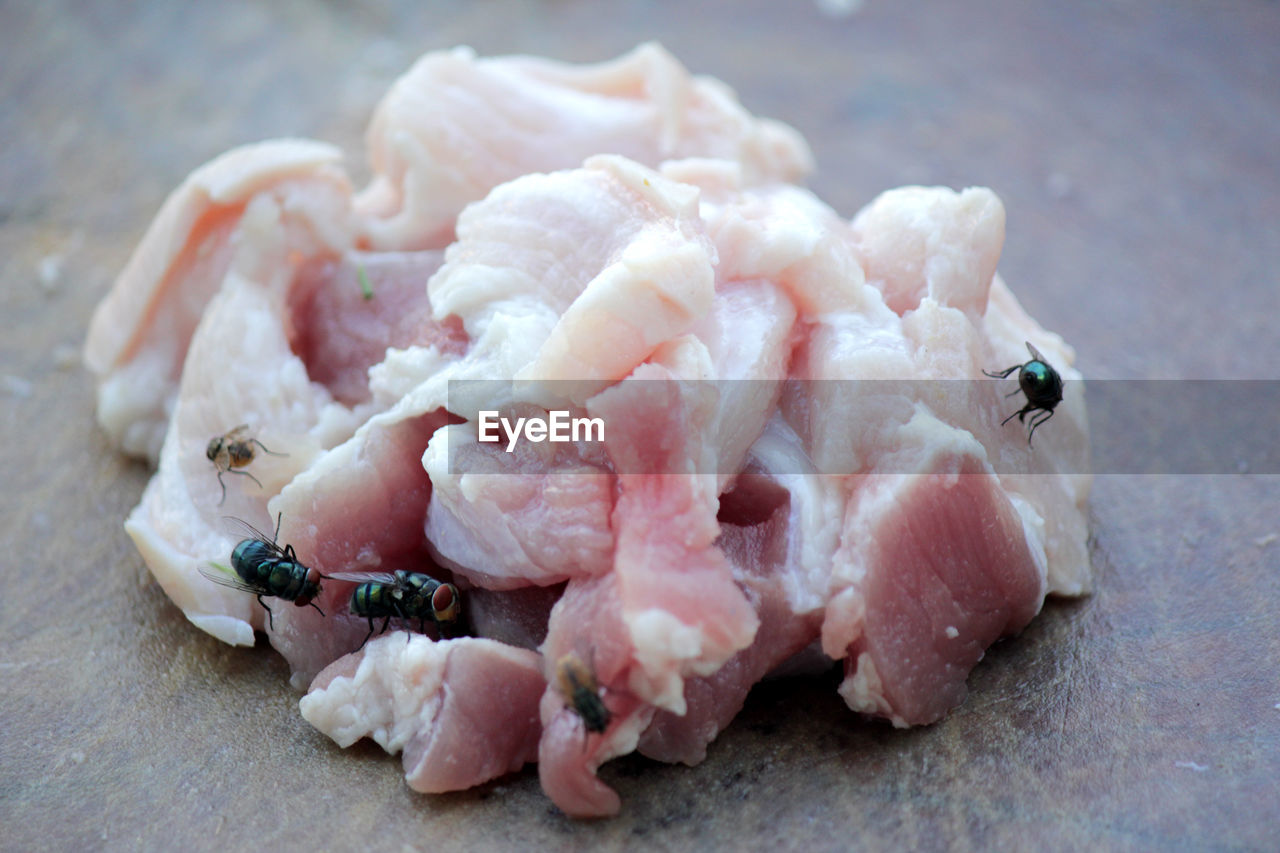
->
[200,515,325,629]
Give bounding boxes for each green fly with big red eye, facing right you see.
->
[326,571,462,652]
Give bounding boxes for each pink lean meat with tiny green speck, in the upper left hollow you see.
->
[287,251,467,406]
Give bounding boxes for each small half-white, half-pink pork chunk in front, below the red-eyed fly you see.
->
[298,631,545,793]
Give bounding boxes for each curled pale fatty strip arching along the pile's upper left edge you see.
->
[84,140,351,462]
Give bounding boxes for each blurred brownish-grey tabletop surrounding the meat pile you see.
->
[0,0,1280,850]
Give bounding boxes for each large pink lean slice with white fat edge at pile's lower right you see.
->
[823,438,1044,726]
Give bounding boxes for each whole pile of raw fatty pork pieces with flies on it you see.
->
[86,45,1091,816]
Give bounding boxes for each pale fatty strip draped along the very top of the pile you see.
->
[357,45,812,250]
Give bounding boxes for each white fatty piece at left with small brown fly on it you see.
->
[124,273,355,646]
